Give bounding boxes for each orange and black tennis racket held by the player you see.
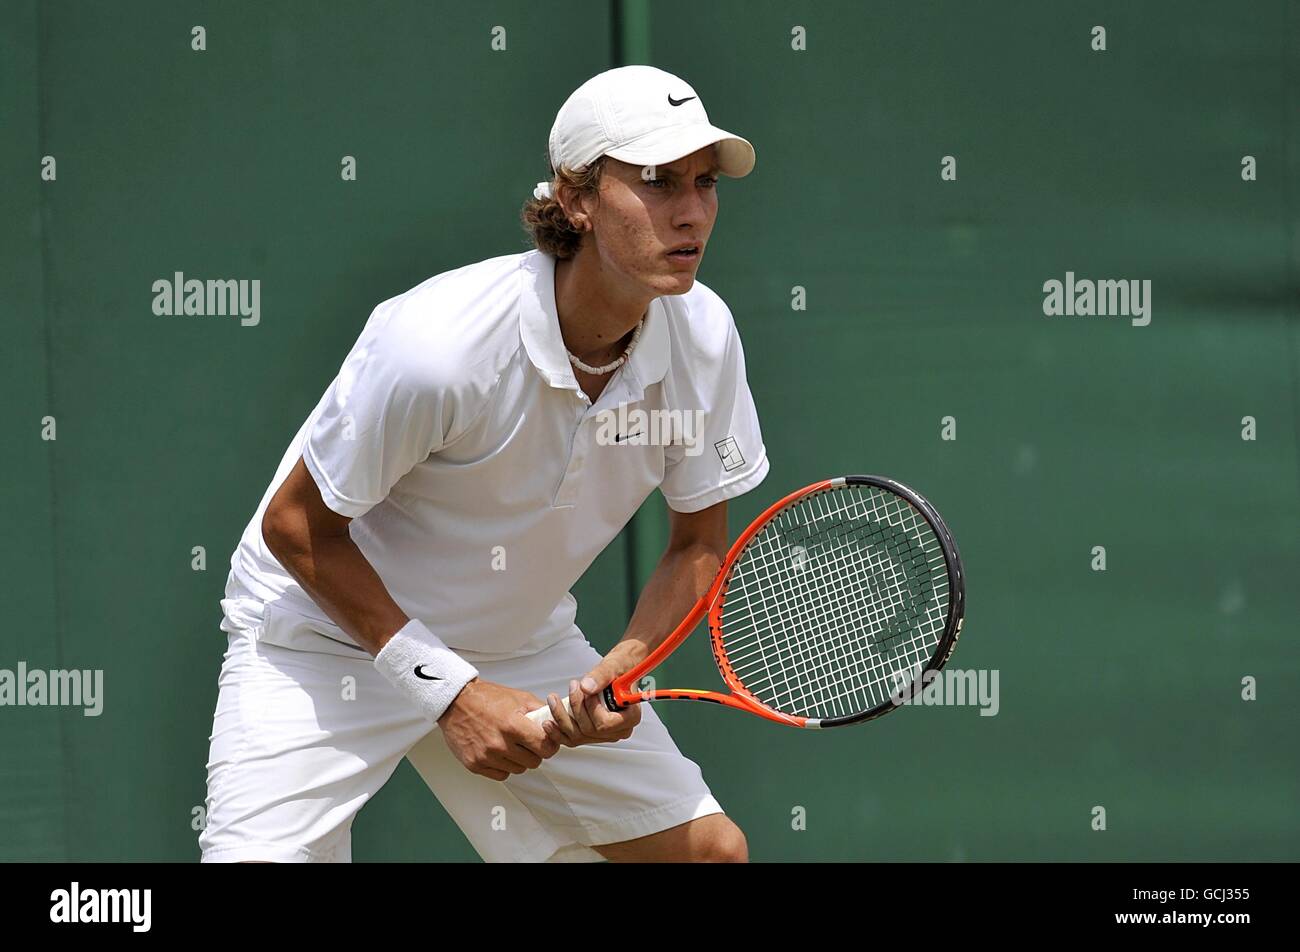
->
[528,476,966,728]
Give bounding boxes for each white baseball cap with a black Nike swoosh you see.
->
[533,66,754,198]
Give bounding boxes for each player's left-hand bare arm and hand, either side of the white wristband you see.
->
[261,459,559,780]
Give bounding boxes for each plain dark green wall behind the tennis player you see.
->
[0,0,1300,861]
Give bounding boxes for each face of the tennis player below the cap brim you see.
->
[592,146,718,297]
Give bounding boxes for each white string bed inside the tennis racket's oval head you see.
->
[720,485,949,718]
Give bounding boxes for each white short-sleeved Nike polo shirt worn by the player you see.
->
[222,251,768,662]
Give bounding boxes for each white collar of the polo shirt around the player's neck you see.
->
[519,251,668,390]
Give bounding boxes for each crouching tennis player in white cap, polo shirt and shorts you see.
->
[199,66,768,862]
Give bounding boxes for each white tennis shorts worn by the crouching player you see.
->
[199,629,722,862]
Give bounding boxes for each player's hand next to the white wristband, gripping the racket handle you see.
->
[438,678,560,780]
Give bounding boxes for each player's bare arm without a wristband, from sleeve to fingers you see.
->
[535,499,728,747]
